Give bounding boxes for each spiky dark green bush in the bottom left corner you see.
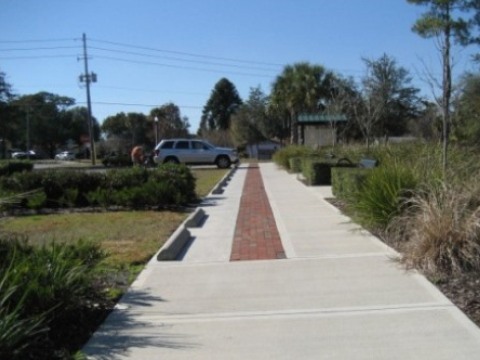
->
[0,235,104,359]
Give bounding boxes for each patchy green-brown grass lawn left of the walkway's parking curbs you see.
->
[0,168,227,267]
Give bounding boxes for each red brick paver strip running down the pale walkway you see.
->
[230,165,285,261]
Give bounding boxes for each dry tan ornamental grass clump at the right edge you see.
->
[393,185,480,275]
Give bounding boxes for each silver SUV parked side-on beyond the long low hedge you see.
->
[153,139,239,168]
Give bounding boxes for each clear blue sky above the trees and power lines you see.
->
[0,0,478,132]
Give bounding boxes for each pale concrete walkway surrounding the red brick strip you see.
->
[84,164,480,360]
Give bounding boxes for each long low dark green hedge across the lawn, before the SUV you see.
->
[0,164,197,209]
